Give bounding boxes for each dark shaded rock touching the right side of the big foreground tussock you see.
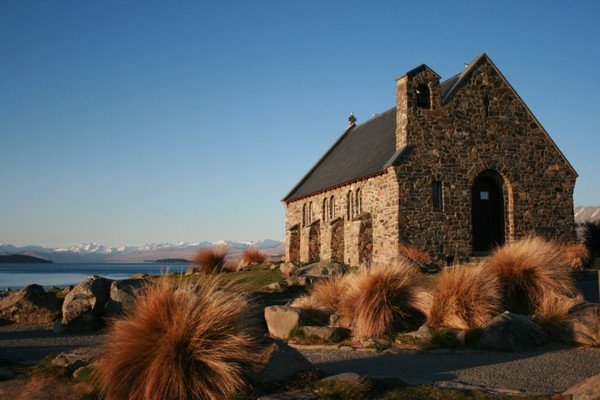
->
[251,340,314,383]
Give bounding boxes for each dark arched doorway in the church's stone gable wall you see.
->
[471,170,505,253]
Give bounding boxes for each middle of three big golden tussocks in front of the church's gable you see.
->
[427,265,502,329]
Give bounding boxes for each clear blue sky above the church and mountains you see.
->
[0,0,600,246]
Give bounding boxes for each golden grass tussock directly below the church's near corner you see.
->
[348,262,429,337]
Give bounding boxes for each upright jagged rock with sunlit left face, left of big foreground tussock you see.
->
[60,275,112,332]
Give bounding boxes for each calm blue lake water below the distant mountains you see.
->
[0,263,189,290]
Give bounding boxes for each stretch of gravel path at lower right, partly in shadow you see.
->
[298,348,600,393]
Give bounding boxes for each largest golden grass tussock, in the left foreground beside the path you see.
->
[96,279,260,400]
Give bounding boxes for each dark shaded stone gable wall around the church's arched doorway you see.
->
[397,55,576,262]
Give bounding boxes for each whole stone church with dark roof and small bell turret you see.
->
[282,54,577,265]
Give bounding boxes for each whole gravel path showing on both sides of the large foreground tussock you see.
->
[0,325,600,393]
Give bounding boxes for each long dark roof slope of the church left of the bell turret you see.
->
[283,107,396,201]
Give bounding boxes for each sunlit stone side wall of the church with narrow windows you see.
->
[285,168,399,265]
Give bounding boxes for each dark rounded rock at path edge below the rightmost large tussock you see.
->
[479,311,547,351]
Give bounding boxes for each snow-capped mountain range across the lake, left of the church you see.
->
[0,239,285,263]
